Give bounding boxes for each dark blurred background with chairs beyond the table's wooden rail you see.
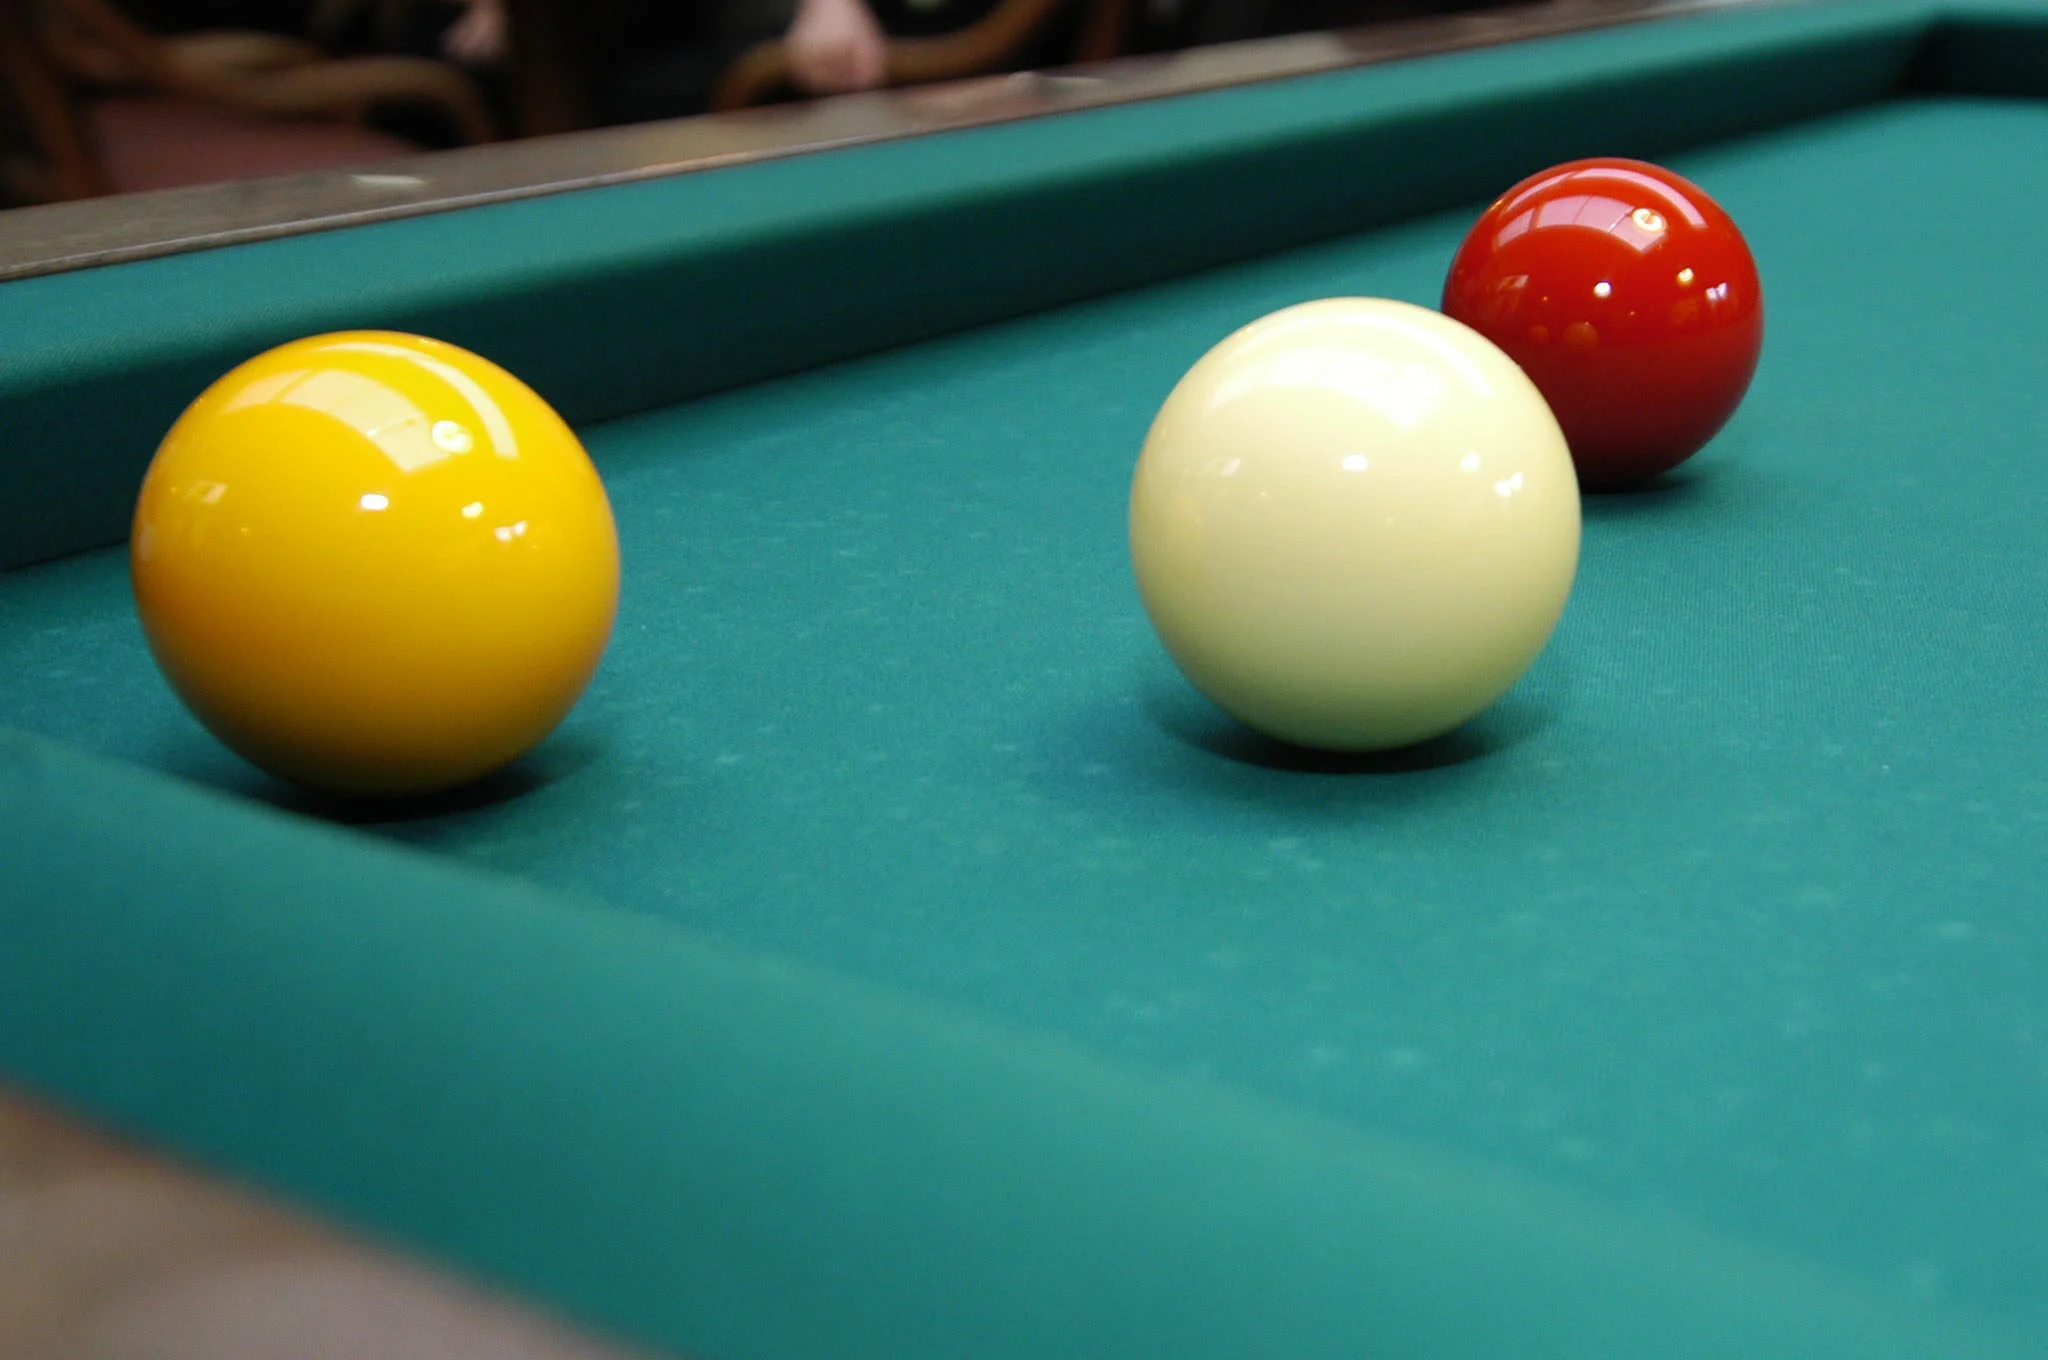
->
[0,0,1507,207]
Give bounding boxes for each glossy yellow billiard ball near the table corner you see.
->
[129,332,618,795]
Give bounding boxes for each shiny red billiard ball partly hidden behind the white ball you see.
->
[1444,160,1763,487]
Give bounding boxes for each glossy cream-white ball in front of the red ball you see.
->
[1130,297,1579,750]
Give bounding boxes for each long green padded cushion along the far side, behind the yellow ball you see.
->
[0,0,1935,569]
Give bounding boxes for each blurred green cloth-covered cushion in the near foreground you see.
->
[0,720,2034,1360]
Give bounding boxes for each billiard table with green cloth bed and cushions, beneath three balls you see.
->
[0,0,2048,1360]
